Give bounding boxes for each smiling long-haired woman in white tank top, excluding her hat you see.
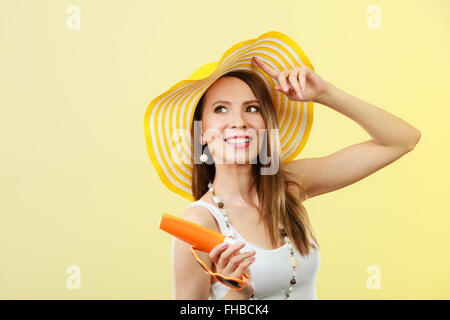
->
[145,30,421,299]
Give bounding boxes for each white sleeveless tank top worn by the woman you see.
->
[188,200,320,300]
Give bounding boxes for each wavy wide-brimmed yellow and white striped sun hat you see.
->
[144,31,314,201]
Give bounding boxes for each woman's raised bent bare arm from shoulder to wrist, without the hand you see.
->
[286,84,421,198]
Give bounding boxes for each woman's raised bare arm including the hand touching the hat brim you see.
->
[254,57,421,198]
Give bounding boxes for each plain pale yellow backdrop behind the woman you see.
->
[0,0,450,299]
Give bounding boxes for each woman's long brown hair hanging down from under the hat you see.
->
[191,71,319,256]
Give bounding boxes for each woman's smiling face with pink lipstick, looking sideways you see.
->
[201,77,266,164]
